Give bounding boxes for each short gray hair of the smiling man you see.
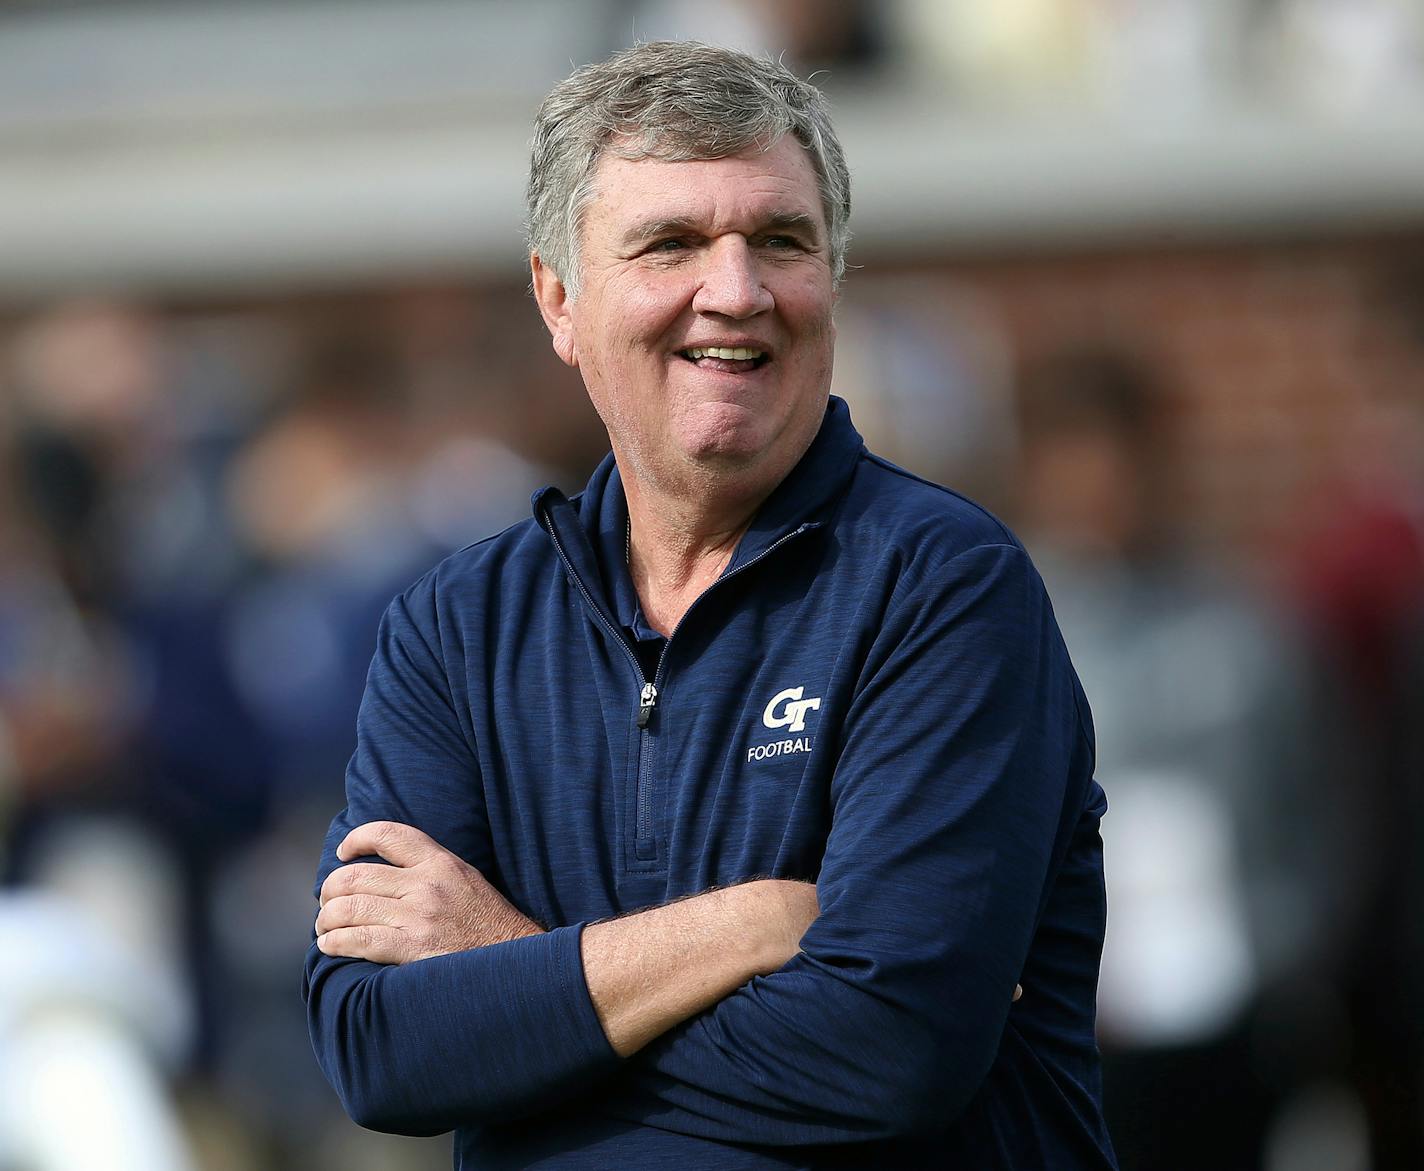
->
[525,41,850,298]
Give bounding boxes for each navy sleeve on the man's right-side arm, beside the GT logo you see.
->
[589,544,1101,1144]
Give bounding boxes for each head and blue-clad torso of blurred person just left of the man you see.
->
[224,333,437,808]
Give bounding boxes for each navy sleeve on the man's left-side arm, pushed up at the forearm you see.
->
[302,574,618,1134]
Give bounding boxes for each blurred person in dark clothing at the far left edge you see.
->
[0,303,157,820]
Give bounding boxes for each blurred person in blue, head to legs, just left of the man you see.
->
[206,337,444,1167]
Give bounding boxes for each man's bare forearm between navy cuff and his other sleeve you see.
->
[582,879,817,1057]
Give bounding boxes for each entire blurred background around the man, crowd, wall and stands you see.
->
[0,0,1424,1171]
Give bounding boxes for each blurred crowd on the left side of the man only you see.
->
[0,293,601,1171]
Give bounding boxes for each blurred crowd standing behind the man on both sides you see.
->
[0,266,1424,1171]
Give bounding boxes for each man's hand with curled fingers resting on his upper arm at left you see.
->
[316,822,543,963]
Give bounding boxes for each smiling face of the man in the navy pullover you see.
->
[535,137,834,504]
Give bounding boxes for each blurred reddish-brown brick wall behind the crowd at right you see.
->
[922,234,1424,560]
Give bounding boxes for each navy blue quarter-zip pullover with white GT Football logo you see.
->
[303,399,1114,1171]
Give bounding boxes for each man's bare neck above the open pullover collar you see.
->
[624,476,762,635]
